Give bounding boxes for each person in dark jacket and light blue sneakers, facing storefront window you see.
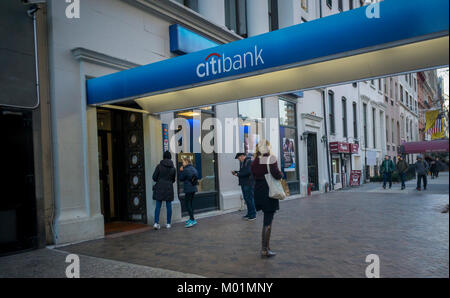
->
[179,158,198,228]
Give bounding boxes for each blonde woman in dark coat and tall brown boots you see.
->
[252,140,283,257]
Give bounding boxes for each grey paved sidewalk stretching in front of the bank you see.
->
[0,173,449,278]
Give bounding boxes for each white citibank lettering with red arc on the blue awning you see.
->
[197,46,264,78]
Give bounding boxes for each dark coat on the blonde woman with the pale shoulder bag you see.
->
[252,156,283,212]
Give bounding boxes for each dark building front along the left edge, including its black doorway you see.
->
[0,0,53,256]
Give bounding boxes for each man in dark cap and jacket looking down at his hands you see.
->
[232,153,256,221]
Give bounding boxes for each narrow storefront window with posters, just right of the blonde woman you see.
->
[279,99,300,194]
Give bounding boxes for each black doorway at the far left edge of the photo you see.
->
[0,109,38,255]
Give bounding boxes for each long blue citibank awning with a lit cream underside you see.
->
[87,0,449,113]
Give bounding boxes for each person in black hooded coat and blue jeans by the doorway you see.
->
[152,151,176,230]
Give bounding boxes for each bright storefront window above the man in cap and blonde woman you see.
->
[238,98,264,154]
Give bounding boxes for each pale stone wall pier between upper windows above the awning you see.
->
[247,0,269,37]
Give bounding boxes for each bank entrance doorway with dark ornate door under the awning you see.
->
[97,109,147,229]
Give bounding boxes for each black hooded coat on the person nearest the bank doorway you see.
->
[152,159,177,202]
